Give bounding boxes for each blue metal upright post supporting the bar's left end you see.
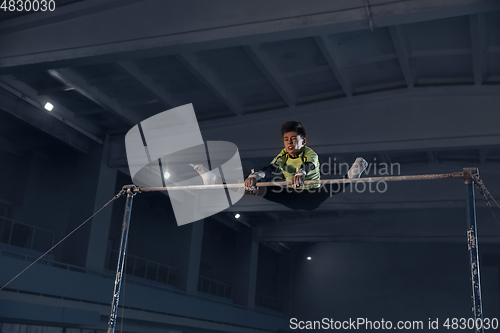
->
[108,185,135,333]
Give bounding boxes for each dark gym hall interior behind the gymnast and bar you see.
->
[0,0,500,333]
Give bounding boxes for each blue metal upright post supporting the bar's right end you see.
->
[464,168,484,333]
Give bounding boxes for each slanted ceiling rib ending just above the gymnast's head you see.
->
[243,45,297,106]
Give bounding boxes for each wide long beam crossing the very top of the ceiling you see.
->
[0,0,500,74]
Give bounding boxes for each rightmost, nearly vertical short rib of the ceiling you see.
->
[469,14,486,85]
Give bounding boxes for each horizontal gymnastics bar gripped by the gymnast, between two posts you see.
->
[130,172,464,192]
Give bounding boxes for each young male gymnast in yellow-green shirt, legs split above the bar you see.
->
[194,121,368,210]
